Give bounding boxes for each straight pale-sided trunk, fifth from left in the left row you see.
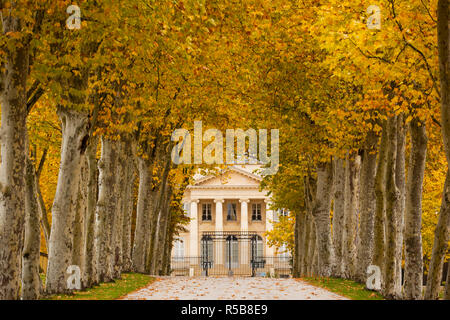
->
[96,137,118,282]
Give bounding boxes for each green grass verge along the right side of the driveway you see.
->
[300,278,384,300]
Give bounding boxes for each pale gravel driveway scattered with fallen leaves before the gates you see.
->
[120,277,346,300]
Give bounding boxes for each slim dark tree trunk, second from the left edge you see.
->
[21,158,41,300]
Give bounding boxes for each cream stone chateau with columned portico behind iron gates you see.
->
[171,165,290,276]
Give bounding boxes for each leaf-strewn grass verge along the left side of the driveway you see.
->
[42,273,155,300]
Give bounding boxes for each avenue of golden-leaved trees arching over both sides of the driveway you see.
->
[0,0,450,299]
